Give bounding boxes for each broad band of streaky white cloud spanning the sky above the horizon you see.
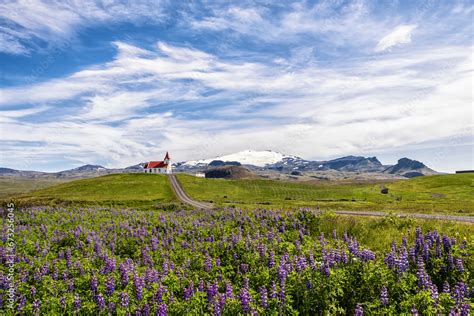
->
[0,43,472,170]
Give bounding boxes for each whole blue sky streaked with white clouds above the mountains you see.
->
[0,0,474,172]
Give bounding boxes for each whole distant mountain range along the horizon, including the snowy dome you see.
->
[0,150,437,178]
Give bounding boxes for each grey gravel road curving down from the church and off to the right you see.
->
[169,174,474,223]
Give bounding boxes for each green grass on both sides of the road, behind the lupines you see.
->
[2,174,474,215]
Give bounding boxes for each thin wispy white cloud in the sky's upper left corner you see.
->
[0,0,164,54]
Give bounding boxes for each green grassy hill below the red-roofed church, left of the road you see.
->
[12,173,174,207]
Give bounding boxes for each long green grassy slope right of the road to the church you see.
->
[178,174,474,215]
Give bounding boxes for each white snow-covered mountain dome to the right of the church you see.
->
[180,150,301,167]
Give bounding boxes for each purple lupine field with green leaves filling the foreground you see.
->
[0,208,474,315]
